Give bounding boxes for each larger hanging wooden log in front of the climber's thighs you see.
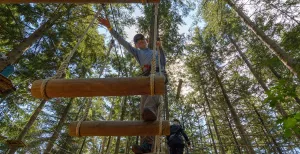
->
[31,76,165,98]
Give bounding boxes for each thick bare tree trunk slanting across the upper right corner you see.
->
[224,0,300,79]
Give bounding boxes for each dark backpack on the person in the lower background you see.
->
[168,125,184,146]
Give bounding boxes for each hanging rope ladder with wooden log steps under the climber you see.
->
[0,0,170,153]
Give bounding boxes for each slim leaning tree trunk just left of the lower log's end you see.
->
[44,98,74,154]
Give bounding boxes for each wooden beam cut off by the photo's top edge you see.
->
[0,0,160,4]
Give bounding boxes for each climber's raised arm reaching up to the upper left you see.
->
[98,18,138,60]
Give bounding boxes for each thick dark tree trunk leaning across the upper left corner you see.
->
[0,5,62,71]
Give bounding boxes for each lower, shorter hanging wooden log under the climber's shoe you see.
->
[69,121,170,136]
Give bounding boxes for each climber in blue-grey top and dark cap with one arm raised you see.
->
[98,18,167,154]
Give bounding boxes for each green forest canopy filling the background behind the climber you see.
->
[0,0,300,153]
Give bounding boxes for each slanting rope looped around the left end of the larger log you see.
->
[41,9,101,100]
